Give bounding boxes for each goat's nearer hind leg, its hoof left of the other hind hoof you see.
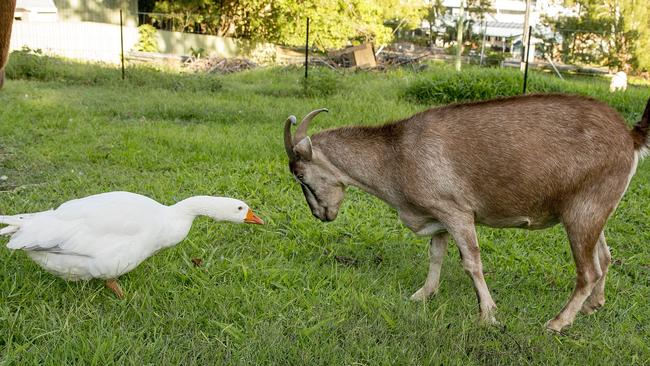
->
[546,212,609,332]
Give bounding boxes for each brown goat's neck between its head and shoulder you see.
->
[313,127,395,203]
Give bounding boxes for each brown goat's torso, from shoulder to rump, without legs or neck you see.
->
[399,95,634,226]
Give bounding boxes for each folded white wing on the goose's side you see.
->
[7,192,165,257]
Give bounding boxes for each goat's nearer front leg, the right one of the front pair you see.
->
[448,222,498,324]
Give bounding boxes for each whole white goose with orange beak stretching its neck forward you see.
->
[0,192,264,298]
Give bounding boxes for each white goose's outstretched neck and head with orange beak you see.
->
[176,196,264,225]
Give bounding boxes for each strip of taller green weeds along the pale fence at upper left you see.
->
[6,48,222,92]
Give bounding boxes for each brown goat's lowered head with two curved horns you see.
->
[284,108,345,221]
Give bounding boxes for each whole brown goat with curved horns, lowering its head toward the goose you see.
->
[284,95,650,332]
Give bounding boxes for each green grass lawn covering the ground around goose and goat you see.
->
[0,57,650,365]
